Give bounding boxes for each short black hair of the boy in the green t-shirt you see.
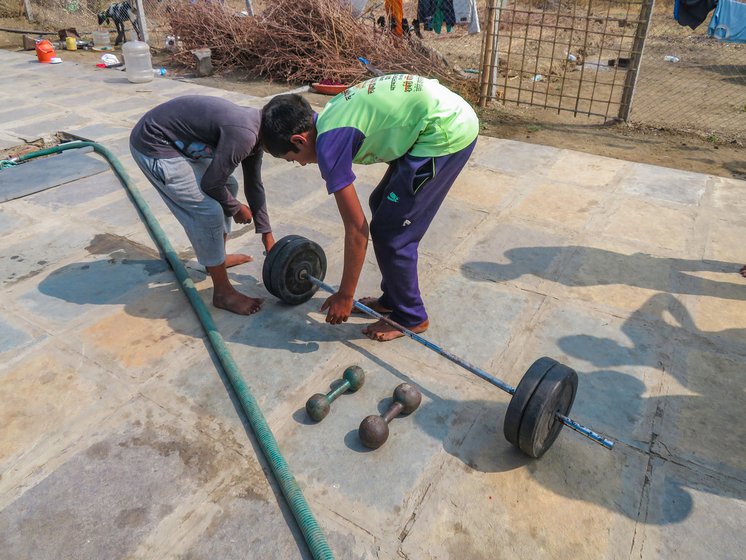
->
[259,93,313,157]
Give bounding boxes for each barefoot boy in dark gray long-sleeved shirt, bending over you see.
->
[130,95,275,315]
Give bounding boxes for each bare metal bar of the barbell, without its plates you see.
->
[299,271,614,449]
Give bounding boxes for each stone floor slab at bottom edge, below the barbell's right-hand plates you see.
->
[396,419,645,560]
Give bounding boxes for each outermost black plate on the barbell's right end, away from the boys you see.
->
[518,363,578,459]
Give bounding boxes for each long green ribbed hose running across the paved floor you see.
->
[8,141,334,560]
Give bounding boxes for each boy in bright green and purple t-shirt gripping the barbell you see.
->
[260,74,479,341]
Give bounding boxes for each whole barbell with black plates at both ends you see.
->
[262,235,614,458]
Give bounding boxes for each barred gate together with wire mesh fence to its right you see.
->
[481,0,746,140]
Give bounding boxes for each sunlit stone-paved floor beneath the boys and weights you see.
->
[0,51,746,560]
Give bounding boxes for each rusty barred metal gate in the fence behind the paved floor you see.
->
[480,0,653,120]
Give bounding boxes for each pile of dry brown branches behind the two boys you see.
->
[169,0,473,95]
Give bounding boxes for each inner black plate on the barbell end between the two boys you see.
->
[271,237,326,305]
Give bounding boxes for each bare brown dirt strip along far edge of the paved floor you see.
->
[0,19,746,179]
